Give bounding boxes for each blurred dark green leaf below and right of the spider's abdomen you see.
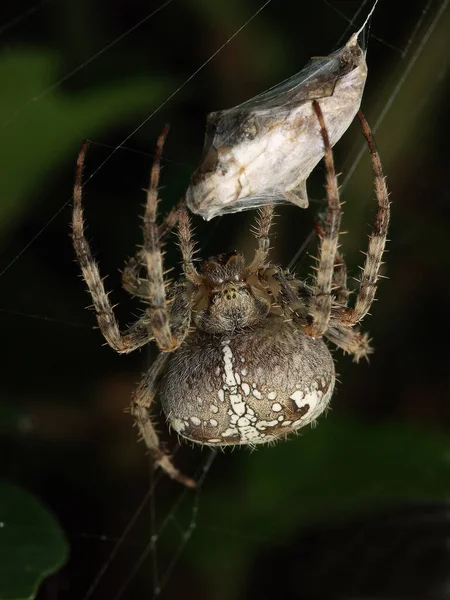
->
[178,419,450,598]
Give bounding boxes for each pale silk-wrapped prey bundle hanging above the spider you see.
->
[186,34,367,221]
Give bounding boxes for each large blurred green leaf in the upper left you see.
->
[0,49,167,228]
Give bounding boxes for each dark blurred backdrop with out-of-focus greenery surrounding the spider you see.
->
[0,0,450,600]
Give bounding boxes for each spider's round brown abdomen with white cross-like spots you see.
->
[161,318,335,446]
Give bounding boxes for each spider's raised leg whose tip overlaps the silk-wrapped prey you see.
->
[305,100,342,338]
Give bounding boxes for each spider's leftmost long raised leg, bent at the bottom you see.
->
[72,143,153,353]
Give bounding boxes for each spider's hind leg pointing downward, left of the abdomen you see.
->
[131,353,195,487]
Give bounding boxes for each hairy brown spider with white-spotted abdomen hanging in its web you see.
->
[72,101,389,487]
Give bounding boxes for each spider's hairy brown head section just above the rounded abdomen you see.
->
[194,252,270,333]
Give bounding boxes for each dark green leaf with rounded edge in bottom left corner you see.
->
[0,483,68,600]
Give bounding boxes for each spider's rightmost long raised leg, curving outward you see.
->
[341,111,390,326]
